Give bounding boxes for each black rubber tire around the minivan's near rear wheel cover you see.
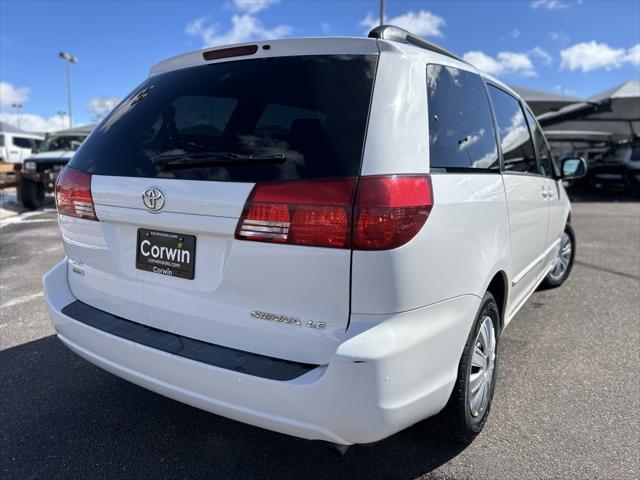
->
[442,292,500,444]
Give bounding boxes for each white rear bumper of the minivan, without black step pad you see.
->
[44,261,480,445]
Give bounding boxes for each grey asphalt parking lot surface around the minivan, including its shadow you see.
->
[0,192,640,479]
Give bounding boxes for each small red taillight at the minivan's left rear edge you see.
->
[56,167,98,220]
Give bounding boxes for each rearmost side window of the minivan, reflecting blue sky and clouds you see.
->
[427,65,500,171]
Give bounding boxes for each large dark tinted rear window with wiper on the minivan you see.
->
[70,55,377,182]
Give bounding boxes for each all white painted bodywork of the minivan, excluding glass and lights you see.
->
[44,38,570,445]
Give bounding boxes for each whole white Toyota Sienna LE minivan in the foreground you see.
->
[44,26,586,446]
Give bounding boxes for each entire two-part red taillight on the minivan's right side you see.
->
[236,175,433,250]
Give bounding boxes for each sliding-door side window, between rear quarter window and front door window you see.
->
[489,85,540,173]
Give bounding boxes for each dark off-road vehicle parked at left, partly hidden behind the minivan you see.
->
[16,126,92,210]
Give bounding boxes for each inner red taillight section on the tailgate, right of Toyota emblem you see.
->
[236,178,356,248]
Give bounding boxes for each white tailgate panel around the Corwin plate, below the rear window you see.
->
[65,175,351,364]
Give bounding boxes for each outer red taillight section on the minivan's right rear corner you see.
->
[353,175,433,250]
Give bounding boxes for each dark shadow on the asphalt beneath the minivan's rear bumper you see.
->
[0,336,462,479]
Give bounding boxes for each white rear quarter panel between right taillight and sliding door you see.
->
[352,174,511,314]
